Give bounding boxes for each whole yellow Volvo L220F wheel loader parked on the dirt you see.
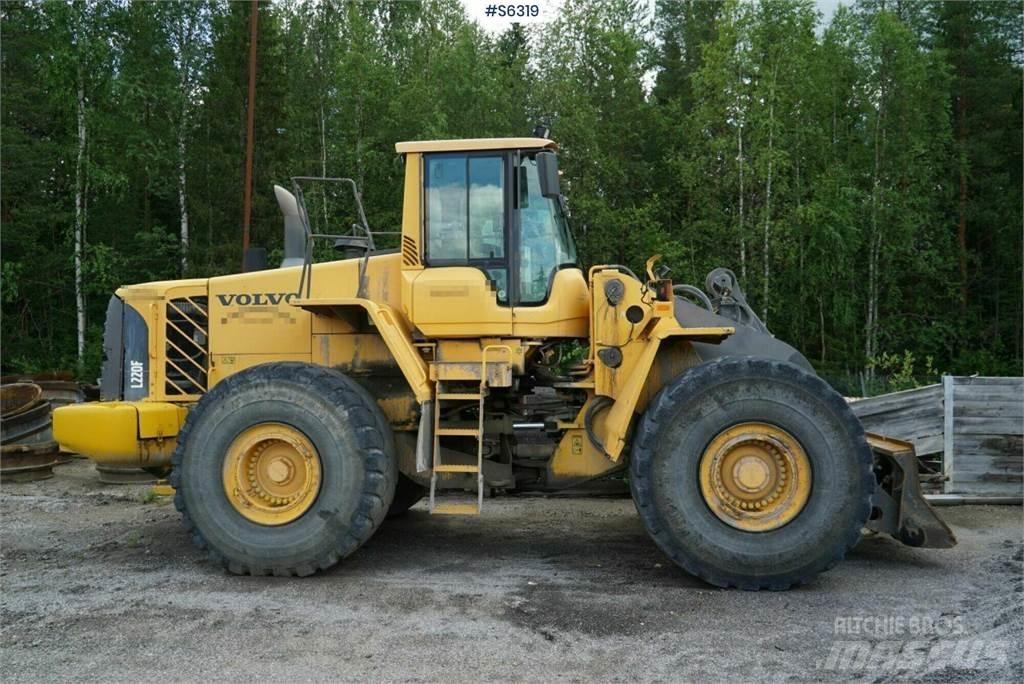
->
[54,137,954,589]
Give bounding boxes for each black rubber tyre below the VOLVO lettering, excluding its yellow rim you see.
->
[171,362,397,576]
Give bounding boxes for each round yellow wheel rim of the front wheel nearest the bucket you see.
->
[700,423,811,532]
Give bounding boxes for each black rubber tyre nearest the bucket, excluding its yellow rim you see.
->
[630,357,874,590]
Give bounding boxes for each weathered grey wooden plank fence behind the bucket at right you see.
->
[850,376,1024,498]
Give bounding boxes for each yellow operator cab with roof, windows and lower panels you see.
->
[396,138,589,338]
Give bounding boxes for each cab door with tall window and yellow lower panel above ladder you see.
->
[410,152,512,338]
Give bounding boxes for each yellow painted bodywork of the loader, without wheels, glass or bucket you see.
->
[54,138,733,482]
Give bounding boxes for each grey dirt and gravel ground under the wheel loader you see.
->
[0,461,1024,682]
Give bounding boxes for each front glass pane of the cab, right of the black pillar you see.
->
[519,157,577,304]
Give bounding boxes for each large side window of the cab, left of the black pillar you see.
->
[425,155,508,302]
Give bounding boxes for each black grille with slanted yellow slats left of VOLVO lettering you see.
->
[164,297,210,396]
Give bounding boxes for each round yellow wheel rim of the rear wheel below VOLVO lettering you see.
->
[223,423,322,525]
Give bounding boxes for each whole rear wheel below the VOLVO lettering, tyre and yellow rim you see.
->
[171,362,397,575]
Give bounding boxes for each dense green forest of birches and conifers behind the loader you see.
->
[0,0,1024,385]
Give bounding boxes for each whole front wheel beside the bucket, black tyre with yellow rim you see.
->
[630,357,873,590]
